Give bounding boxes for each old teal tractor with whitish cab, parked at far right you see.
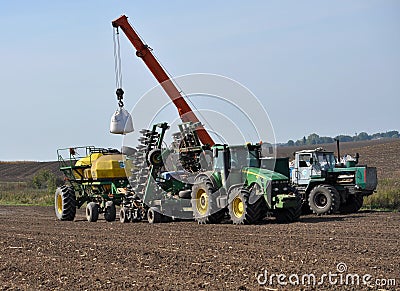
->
[291,148,378,215]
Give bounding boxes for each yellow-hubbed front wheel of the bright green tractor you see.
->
[228,187,265,224]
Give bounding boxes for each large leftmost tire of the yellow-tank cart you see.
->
[54,185,76,221]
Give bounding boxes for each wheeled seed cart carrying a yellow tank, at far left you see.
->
[54,146,129,222]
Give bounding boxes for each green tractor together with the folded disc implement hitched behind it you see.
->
[120,123,302,224]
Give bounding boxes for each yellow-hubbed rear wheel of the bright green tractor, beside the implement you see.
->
[190,177,225,224]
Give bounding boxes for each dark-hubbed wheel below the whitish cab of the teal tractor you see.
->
[308,185,340,215]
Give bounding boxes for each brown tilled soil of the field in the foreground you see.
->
[0,206,400,290]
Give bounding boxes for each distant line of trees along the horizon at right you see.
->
[281,130,400,146]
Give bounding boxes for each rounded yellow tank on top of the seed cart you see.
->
[91,155,131,180]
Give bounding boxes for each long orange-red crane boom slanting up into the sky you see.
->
[112,15,215,146]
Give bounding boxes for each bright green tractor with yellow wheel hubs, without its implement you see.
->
[191,143,302,224]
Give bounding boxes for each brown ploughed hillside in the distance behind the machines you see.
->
[0,139,400,182]
